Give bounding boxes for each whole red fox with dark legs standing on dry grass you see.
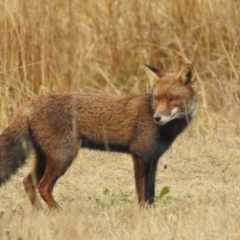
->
[0,64,197,209]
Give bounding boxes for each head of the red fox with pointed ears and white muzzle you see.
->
[144,64,197,125]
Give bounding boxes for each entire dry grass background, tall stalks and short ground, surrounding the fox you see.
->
[0,0,240,240]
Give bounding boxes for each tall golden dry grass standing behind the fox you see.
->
[0,0,240,130]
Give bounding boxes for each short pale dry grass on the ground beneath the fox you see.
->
[0,126,240,240]
